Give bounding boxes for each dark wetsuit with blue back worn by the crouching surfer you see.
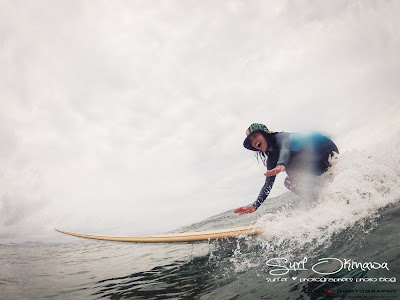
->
[253,132,339,209]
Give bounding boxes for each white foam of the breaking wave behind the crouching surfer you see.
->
[257,136,400,253]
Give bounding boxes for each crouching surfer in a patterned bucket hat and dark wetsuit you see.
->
[234,123,339,214]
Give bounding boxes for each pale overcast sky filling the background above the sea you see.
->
[0,0,400,242]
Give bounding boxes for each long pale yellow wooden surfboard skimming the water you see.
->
[56,225,261,243]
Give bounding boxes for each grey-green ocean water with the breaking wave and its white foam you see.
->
[0,147,400,299]
